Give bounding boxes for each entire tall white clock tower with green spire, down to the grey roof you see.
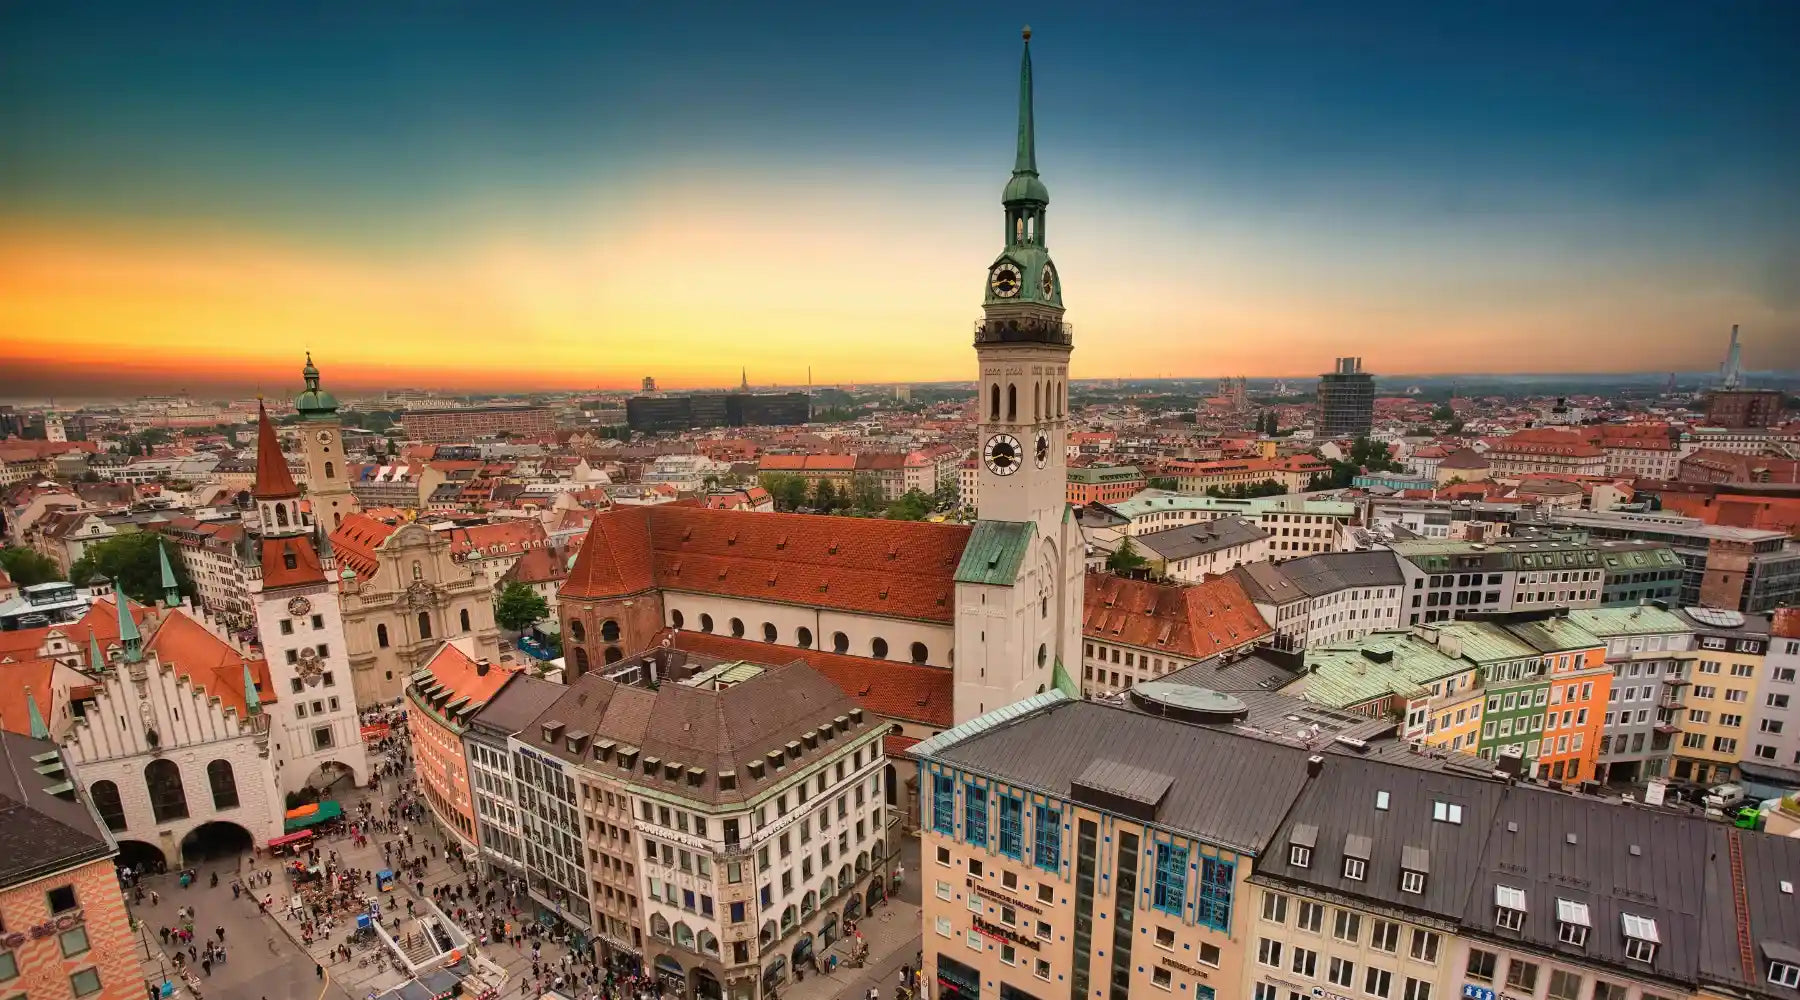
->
[954,27,1085,723]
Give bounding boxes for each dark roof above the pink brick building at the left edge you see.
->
[0,732,115,888]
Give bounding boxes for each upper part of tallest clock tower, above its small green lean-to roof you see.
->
[976,27,1073,531]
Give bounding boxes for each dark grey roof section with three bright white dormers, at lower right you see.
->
[1463,784,1732,984]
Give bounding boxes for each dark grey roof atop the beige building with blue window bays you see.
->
[914,700,1309,854]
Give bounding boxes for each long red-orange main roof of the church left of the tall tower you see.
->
[562,504,972,622]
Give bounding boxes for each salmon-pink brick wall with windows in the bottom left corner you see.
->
[0,858,144,1000]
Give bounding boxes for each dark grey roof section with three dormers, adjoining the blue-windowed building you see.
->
[1256,754,1507,919]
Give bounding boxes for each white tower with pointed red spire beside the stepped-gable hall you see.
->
[254,406,369,793]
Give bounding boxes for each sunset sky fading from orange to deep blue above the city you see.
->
[0,0,1800,397]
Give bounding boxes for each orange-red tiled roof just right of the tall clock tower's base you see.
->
[1082,574,1269,660]
